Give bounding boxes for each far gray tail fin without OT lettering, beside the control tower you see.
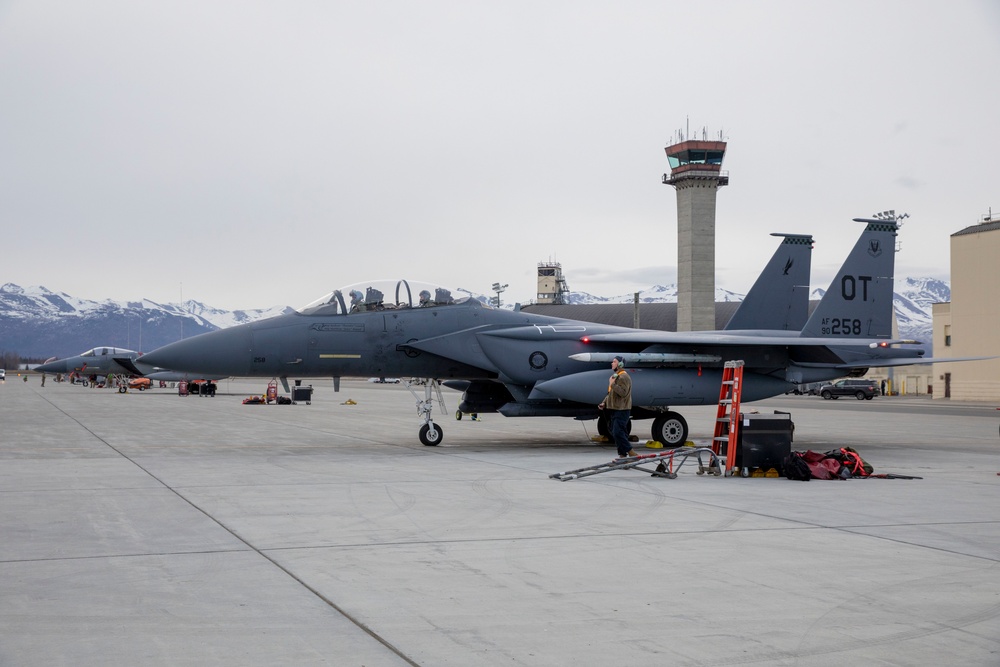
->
[726,234,813,331]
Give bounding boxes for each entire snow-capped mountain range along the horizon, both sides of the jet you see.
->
[0,278,951,358]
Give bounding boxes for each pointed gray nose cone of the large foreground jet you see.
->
[141,325,252,376]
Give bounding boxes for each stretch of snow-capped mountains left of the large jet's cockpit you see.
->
[0,283,291,358]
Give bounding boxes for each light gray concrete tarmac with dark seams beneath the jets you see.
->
[0,373,1000,667]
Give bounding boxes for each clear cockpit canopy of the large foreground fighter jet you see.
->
[297,279,486,315]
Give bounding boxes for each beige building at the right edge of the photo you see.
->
[933,218,1000,402]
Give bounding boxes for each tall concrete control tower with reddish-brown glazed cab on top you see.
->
[663,140,729,331]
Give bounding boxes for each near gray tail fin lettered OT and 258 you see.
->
[802,218,899,339]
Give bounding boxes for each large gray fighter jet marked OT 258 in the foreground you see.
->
[143,218,968,446]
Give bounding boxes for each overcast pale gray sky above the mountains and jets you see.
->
[0,0,1000,309]
